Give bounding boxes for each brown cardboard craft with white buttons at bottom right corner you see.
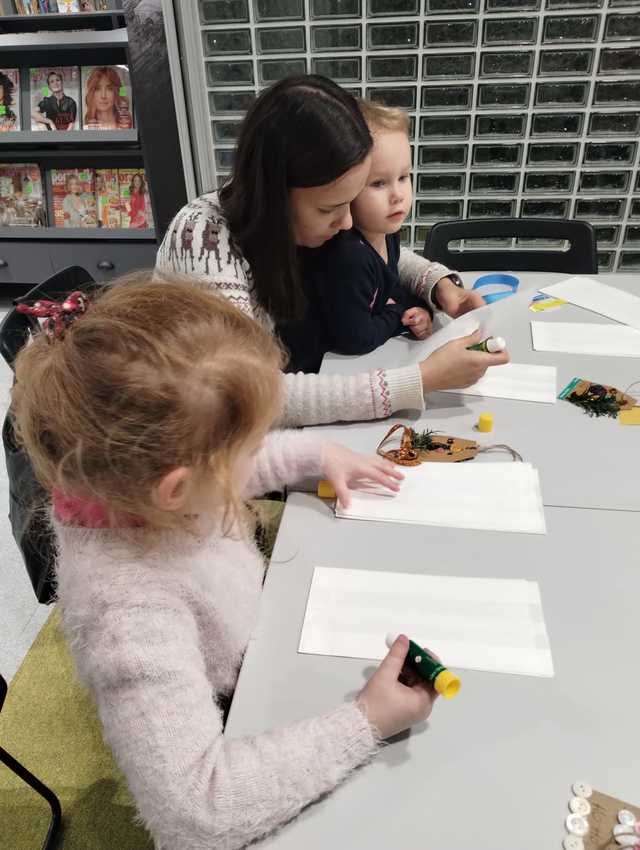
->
[562,782,640,850]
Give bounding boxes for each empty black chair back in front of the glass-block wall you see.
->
[424,218,598,274]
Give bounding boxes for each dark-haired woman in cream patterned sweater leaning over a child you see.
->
[157,75,496,425]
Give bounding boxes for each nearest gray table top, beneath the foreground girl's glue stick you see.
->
[227,493,640,850]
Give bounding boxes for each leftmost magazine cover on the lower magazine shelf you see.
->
[0,163,47,227]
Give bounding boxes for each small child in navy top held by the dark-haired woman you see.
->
[283,101,461,371]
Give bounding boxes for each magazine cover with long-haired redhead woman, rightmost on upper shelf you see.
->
[82,65,133,130]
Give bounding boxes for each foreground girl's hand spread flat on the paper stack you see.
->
[323,443,404,508]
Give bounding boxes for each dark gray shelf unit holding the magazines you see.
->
[0,0,157,293]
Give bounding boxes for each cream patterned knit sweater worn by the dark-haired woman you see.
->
[156,192,456,426]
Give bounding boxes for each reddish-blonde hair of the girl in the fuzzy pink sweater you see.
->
[12,272,282,530]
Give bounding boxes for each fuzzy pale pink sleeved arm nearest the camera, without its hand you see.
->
[65,588,378,850]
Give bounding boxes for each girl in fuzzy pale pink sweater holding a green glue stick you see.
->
[12,274,433,850]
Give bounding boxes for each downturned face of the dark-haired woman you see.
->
[289,154,371,248]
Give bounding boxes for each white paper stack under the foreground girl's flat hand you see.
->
[336,461,546,534]
